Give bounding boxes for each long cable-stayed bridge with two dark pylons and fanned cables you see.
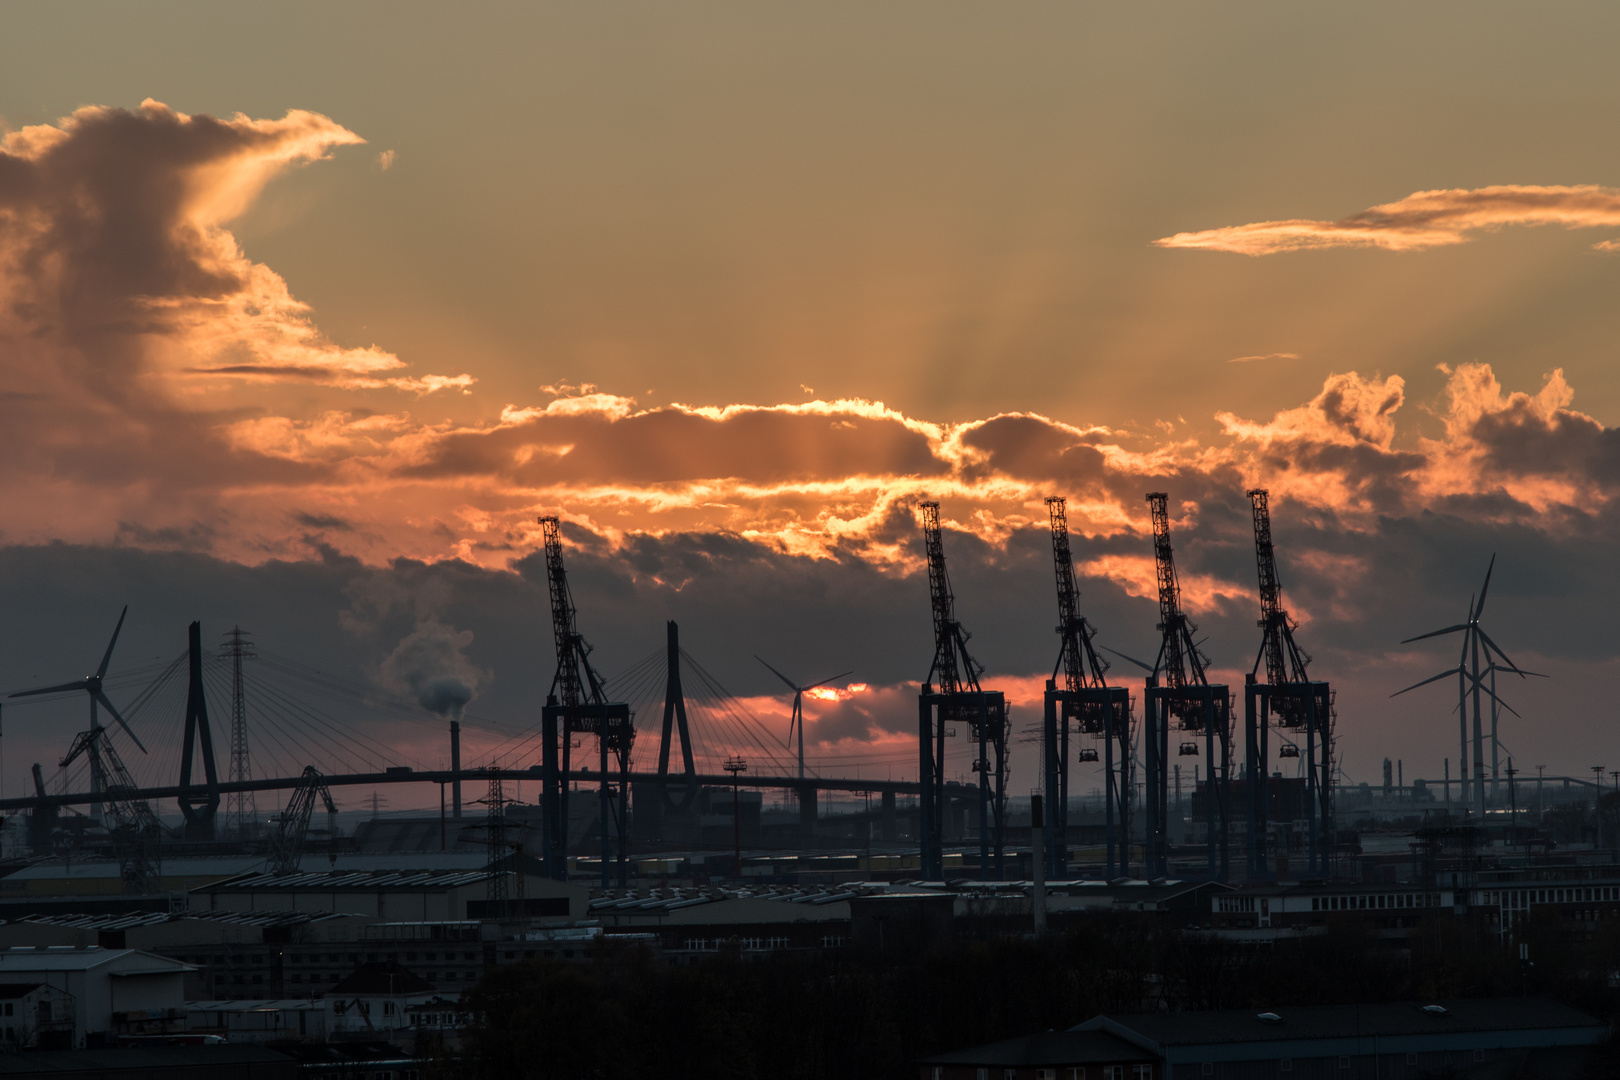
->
[0,623,919,880]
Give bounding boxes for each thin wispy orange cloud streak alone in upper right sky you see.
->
[1153,185,1620,256]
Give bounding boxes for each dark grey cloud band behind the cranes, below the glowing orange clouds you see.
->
[0,492,1620,809]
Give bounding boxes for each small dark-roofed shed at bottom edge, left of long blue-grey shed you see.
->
[917,1031,1158,1080]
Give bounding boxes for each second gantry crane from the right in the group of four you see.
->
[1142,492,1231,881]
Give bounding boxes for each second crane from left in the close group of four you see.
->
[1042,495,1131,879]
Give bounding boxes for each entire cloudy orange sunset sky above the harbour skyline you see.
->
[0,3,1620,805]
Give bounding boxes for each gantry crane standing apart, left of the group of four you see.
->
[539,517,635,889]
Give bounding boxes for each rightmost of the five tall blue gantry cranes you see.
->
[1243,487,1333,878]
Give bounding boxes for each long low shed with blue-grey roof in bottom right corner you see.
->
[1071,997,1609,1080]
